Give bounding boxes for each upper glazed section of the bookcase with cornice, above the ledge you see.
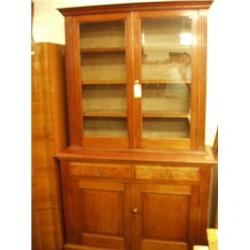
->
[60,1,210,150]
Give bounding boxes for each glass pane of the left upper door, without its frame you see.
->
[80,21,127,137]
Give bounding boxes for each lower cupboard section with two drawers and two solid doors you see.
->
[61,161,210,250]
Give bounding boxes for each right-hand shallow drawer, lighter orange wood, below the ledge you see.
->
[135,165,200,181]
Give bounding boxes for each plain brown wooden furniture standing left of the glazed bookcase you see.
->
[32,43,67,250]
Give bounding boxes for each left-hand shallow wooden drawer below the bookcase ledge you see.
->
[69,162,132,179]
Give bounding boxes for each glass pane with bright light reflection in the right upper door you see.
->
[141,17,193,139]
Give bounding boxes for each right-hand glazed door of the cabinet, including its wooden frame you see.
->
[136,11,199,149]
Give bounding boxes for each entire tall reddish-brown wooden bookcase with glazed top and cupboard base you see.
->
[56,1,216,250]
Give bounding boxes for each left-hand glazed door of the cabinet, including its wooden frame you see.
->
[65,14,132,147]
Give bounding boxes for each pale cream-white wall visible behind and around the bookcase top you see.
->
[33,0,217,146]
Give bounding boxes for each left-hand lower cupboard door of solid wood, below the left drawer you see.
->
[78,180,130,249]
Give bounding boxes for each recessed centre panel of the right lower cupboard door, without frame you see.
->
[142,193,189,241]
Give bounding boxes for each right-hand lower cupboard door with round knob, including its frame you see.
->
[132,184,199,250]
